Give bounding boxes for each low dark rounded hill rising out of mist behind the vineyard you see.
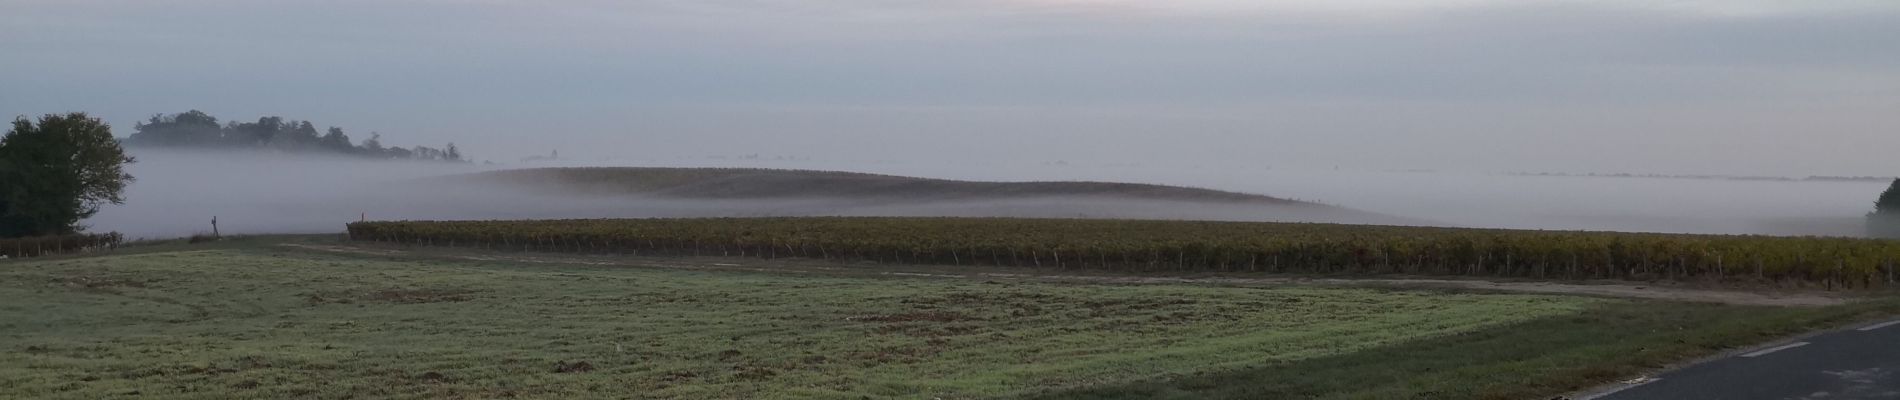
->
[437,167,1423,226]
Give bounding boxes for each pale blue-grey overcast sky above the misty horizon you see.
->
[0,0,1900,174]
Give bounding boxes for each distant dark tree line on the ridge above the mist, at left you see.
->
[125,110,467,161]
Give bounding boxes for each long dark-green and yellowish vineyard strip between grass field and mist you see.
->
[350,218,1900,288]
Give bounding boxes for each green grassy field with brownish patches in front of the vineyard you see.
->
[0,239,1892,398]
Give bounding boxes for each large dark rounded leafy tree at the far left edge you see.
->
[0,112,133,237]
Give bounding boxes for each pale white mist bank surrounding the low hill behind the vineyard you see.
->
[86,150,1885,237]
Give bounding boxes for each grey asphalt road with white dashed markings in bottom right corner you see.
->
[1583,320,1900,400]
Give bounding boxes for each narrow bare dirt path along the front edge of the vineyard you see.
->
[279,243,1849,307]
